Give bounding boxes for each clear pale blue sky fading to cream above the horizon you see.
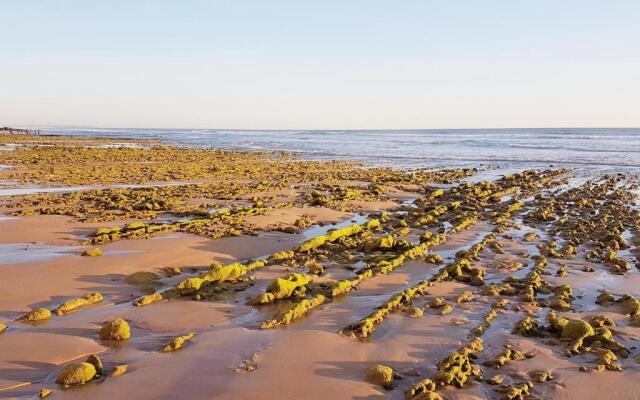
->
[0,0,640,129]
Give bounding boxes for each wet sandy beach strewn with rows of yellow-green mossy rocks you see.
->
[0,132,640,400]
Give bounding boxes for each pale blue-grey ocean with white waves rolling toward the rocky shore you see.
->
[40,127,640,172]
